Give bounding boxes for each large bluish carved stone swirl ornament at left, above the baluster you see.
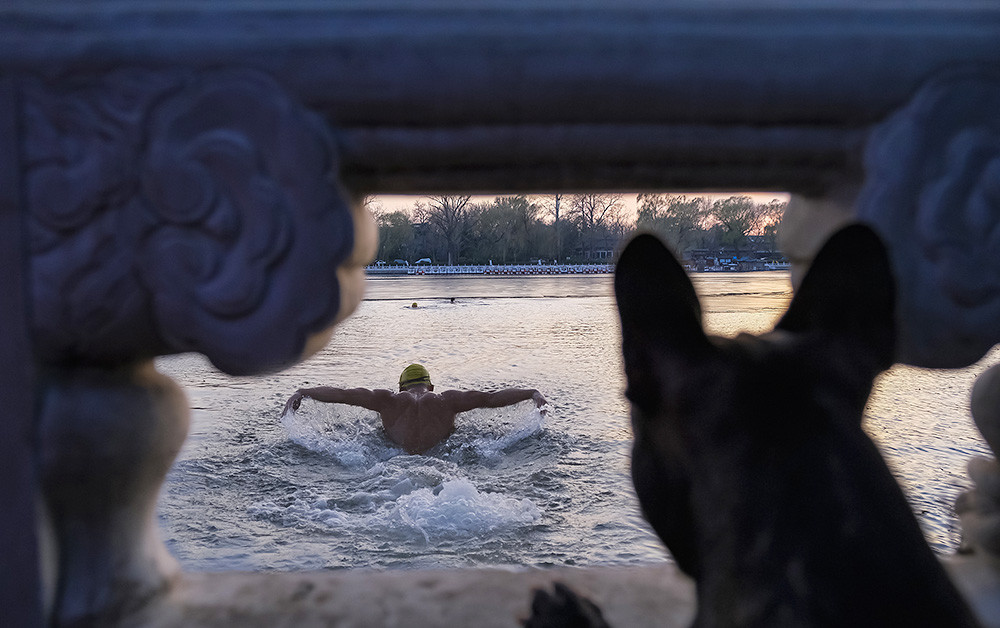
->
[23,69,354,374]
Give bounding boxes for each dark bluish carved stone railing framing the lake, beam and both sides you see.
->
[0,0,1000,626]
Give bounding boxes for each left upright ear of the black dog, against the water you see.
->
[615,234,709,411]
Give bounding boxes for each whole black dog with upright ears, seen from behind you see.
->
[534,225,976,628]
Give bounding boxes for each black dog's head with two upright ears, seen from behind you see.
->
[615,225,895,578]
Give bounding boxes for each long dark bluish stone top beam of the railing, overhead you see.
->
[0,0,1000,194]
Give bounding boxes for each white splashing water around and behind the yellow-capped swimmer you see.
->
[258,400,545,545]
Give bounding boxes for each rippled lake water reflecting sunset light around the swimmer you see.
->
[157,272,1000,571]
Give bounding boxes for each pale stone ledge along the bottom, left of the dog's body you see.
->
[122,563,695,628]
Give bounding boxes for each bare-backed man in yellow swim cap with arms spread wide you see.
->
[284,364,545,454]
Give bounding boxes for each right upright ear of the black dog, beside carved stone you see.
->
[776,224,896,371]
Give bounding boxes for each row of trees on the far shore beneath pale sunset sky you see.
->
[365,194,785,264]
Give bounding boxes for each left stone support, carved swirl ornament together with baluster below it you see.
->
[17,68,376,626]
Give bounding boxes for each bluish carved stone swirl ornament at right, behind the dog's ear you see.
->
[857,68,1000,367]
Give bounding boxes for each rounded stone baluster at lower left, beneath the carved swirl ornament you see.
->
[39,361,189,626]
